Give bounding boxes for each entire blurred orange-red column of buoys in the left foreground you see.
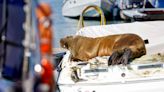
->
[35,3,55,92]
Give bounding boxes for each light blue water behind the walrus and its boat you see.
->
[41,0,126,48]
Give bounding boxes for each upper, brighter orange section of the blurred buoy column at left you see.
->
[36,3,53,55]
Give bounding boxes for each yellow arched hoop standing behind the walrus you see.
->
[78,5,106,30]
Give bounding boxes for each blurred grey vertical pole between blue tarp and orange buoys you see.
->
[22,0,35,92]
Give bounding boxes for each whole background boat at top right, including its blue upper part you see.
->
[120,0,164,20]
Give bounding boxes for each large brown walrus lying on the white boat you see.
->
[60,33,146,65]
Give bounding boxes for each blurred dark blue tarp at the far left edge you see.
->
[0,0,25,80]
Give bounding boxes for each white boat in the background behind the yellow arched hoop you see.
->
[62,0,114,17]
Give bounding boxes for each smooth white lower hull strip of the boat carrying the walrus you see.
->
[60,80,164,92]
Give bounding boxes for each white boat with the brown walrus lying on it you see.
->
[57,21,164,92]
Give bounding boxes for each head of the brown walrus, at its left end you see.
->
[60,36,73,49]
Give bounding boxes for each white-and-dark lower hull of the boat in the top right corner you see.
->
[121,8,164,20]
